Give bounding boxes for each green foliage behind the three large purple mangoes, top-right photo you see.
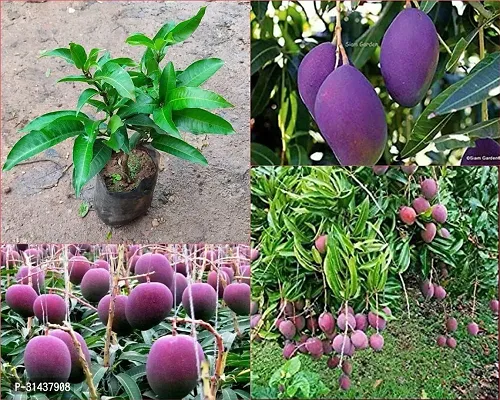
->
[251,1,500,165]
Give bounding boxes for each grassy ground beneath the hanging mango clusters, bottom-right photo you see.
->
[252,297,498,399]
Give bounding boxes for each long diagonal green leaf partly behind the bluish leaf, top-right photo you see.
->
[401,53,500,158]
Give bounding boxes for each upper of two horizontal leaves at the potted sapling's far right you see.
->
[168,87,233,111]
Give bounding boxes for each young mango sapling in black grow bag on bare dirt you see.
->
[3,7,234,226]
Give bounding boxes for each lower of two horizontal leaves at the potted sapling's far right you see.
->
[172,108,234,135]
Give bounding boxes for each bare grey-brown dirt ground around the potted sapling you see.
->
[1,1,250,243]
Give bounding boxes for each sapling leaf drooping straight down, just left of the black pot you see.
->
[73,131,96,197]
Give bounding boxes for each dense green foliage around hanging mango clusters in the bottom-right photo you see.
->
[251,167,498,318]
